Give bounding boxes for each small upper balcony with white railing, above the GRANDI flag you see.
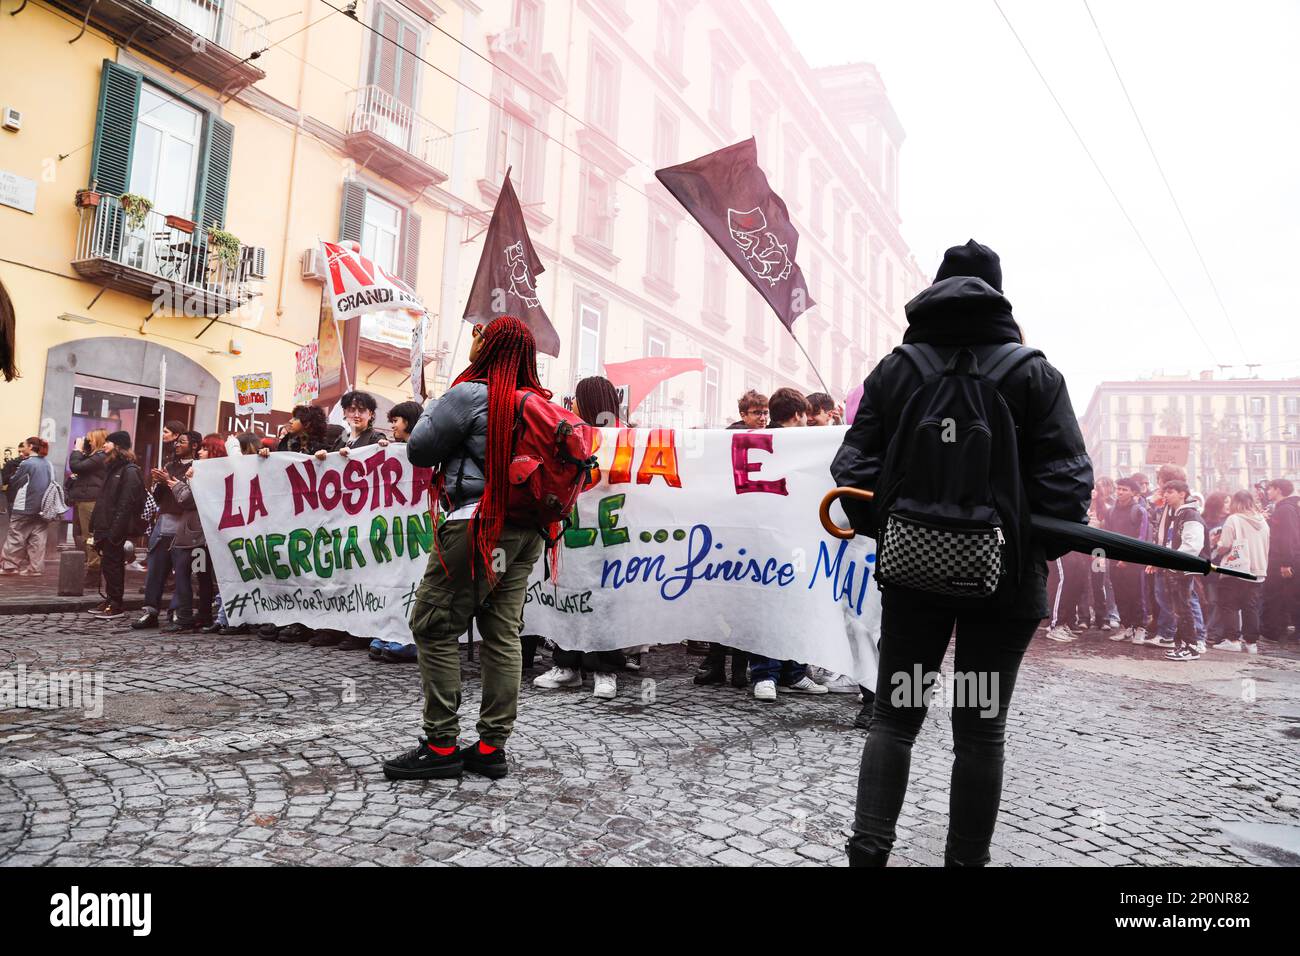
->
[345,86,451,190]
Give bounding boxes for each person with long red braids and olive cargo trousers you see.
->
[384,316,551,780]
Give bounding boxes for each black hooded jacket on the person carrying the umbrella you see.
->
[831,276,1092,618]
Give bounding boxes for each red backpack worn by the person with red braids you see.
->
[506,389,595,545]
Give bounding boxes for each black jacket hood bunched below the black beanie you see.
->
[902,276,1022,345]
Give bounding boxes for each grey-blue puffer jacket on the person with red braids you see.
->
[407,381,488,511]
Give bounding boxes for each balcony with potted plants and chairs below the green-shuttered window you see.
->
[73,194,265,317]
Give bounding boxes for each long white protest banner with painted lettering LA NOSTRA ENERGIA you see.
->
[194,428,880,685]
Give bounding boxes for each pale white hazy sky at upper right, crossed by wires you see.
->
[771,0,1300,414]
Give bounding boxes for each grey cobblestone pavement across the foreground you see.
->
[0,614,1300,866]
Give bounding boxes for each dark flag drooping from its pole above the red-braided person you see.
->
[465,170,560,355]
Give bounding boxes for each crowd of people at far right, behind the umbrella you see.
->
[1045,464,1300,661]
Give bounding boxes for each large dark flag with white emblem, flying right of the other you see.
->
[655,137,814,329]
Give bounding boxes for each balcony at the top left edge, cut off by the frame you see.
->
[52,0,269,95]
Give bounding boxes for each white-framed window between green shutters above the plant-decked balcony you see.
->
[130,83,203,219]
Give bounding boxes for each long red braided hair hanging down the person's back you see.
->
[438,315,551,583]
